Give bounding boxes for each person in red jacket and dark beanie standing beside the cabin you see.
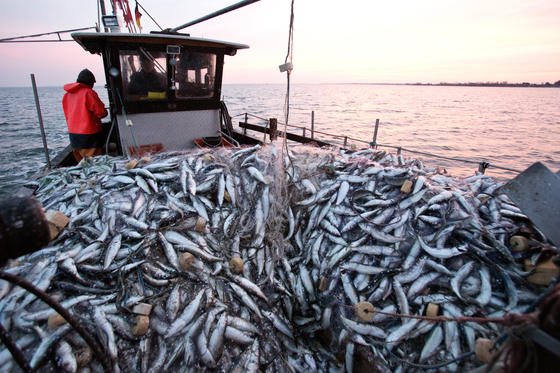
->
[62,69,108,162]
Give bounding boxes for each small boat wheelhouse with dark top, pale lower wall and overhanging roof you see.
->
[72,32,248,156]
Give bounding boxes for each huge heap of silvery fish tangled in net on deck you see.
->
[0,145,546,372]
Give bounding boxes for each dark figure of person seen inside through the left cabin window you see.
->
[127,56,165,98]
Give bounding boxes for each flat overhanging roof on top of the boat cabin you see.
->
[72,32,249,55]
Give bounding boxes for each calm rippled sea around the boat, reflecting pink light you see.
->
[0,84,560,197]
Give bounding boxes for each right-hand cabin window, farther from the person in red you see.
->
[170,51,216,99]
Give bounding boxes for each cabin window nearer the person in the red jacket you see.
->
[120,48,167,101]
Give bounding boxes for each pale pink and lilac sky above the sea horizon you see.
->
[0,0,560,87]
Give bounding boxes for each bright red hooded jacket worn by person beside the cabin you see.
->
[62,83,107,134]
